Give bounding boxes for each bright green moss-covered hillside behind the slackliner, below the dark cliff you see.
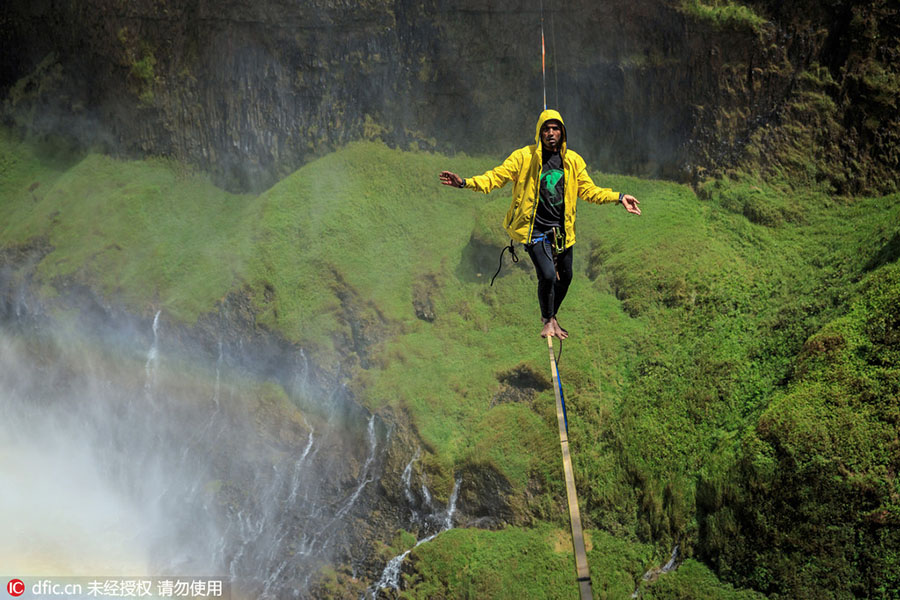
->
[0,129,900,598]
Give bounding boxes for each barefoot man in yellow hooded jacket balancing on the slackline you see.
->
[440,110,641,339]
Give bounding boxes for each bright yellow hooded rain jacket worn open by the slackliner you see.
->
[465,110,619,248]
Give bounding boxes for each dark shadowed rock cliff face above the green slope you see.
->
[0,0,900,192]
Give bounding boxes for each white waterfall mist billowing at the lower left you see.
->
[0,298,389,598]
